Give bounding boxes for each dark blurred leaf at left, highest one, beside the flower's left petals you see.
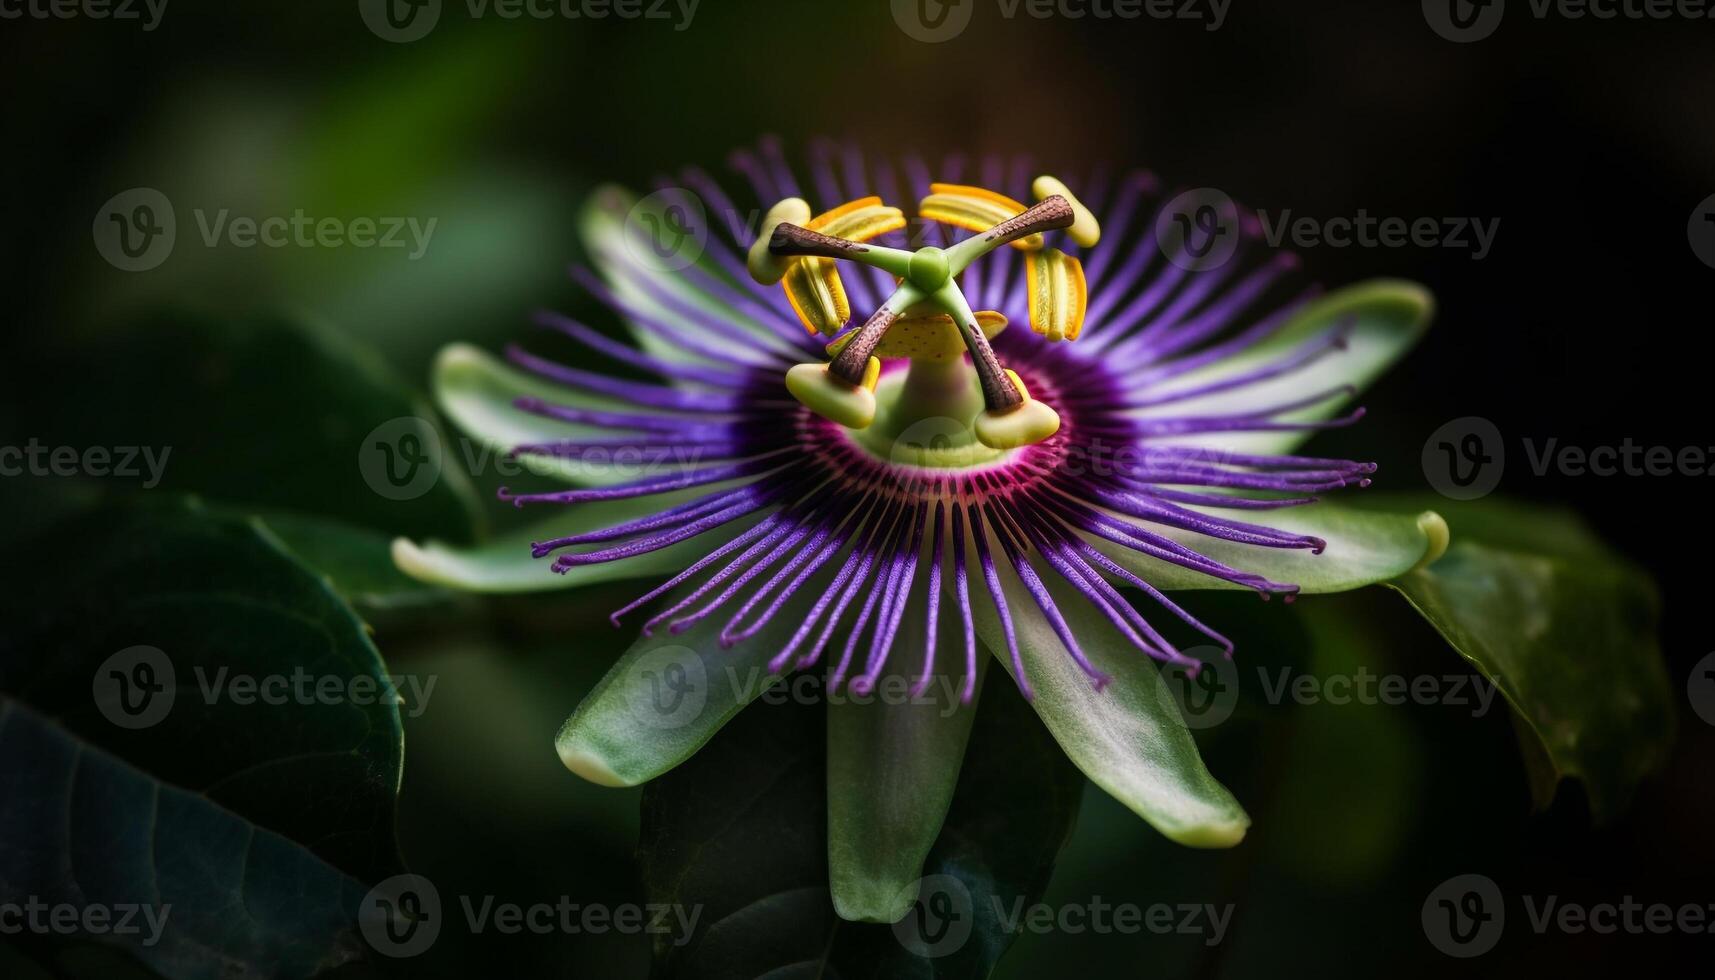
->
[6,314,477,541]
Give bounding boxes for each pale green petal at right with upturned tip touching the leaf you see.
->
[1091,491,1447,594]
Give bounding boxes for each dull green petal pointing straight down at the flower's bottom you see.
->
[828,628,981,922]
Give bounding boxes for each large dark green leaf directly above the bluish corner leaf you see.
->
[0,501,404,877]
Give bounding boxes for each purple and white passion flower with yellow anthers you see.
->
[394,141,1447,918]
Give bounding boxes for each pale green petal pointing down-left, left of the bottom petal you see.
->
[554,582,815,786]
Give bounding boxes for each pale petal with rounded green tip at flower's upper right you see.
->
[1135,280,1435,453]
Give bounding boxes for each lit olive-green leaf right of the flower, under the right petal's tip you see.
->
[1389,499,1674,820]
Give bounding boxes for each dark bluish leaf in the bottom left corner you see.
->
[0,695,364,980]
